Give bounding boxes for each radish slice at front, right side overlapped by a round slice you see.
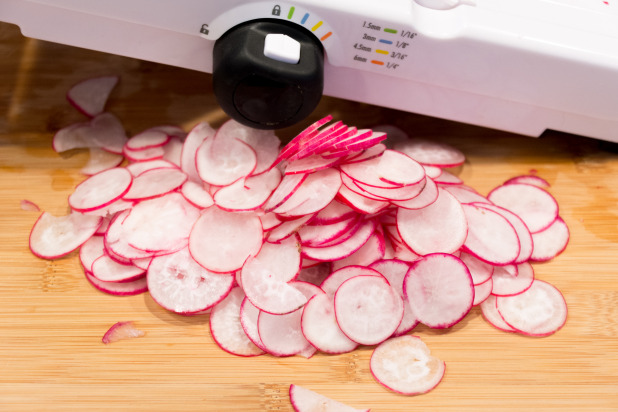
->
[301,292,358,354]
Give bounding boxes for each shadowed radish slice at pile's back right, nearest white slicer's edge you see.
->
[393,139,466,167]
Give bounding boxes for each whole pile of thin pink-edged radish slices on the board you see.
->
[30,77,569,402]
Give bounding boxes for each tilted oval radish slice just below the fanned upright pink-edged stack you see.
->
[273,169,341,216]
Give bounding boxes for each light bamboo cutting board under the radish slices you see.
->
[0,25,618,412]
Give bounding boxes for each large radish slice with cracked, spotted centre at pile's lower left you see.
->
[147,248,234,314]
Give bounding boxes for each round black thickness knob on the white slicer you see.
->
[213,20,324,129]
